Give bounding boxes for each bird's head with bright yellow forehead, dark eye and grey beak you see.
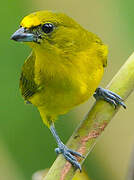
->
[11,11,92,52]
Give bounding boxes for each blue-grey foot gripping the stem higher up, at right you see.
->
[94,87,126,109]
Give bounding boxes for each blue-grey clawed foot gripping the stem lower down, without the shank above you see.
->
[55,143,84,172]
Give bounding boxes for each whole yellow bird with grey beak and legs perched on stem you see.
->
[11,11,125,171]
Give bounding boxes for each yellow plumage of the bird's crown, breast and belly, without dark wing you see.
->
[18,11,107,126]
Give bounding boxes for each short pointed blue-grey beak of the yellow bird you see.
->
[11,27,36,42]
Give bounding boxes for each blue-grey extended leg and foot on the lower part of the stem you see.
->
[50,124,84,172]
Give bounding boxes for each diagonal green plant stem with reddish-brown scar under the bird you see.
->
[43,53,134,180]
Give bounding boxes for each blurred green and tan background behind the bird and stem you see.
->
[0,0,134,180]
